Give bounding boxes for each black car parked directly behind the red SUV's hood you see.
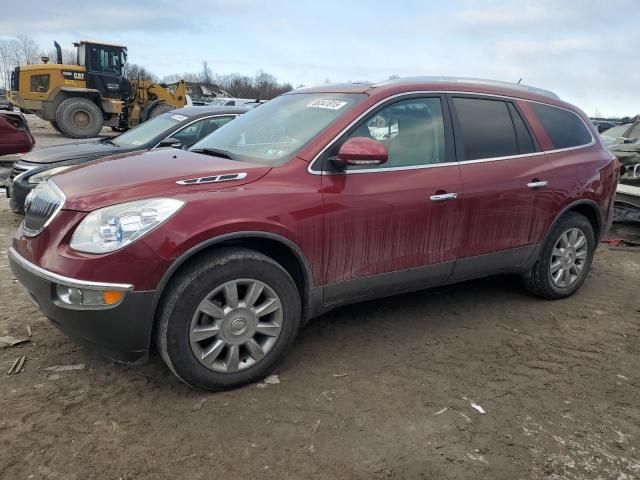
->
[6,106,251,214]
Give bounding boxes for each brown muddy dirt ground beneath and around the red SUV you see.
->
[0,122,640,480]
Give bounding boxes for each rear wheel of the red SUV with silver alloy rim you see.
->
[524,212,596,300]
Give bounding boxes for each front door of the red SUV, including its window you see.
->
[322,96,461,304]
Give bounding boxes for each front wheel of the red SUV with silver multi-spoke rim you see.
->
[156,248,301,391]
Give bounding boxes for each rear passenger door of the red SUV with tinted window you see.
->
[449,95,552,279]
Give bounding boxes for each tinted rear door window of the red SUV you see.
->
[453,98,528,160]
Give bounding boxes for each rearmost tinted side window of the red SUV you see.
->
[531,103,592,148]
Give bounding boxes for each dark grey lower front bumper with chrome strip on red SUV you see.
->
[9,248,155,363]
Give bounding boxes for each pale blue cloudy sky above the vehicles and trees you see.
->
[0,0,640,116]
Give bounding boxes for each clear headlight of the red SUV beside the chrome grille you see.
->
[71,198,184,253]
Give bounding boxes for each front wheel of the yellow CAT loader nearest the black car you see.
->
[56,97,104,138]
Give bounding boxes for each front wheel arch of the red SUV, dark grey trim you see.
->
[152,231,314,332]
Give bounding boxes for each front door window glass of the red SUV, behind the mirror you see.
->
[342,98,446,170]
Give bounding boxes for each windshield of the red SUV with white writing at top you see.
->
[190,93,366,165]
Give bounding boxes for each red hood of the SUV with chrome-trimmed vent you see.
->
[52,148,272,212]
